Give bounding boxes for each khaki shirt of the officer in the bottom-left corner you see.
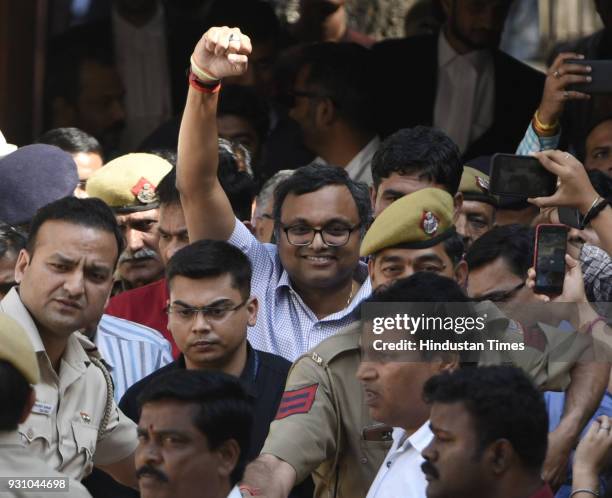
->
[0,431,91,498]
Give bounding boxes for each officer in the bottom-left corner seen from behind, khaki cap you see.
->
[0,313,90,498]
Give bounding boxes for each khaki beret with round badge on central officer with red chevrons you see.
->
[360,188,455,256]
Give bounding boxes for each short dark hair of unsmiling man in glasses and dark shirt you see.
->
[166,238,251,299]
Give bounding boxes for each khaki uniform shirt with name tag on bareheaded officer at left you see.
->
[0,288,138,480]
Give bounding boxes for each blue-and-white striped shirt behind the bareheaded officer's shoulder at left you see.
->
[94,314,172,403]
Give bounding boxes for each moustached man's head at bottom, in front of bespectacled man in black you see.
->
[136,370,253,498]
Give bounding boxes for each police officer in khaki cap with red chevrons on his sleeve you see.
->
[242,188,608,498]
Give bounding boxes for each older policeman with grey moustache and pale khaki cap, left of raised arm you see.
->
[87,153,172,290]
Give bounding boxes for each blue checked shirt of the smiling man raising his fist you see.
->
[228,220,372,361]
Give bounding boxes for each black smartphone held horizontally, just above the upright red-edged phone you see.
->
[489,154,557,198]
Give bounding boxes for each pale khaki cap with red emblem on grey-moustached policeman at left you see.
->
[86,152,172,213]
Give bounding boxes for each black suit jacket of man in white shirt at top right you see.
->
[372,35,545,159]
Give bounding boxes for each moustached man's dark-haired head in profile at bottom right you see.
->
[422,366,552,498]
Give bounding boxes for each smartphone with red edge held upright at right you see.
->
[533,225,567,296]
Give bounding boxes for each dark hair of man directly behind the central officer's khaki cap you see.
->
[372,126,463,196]
